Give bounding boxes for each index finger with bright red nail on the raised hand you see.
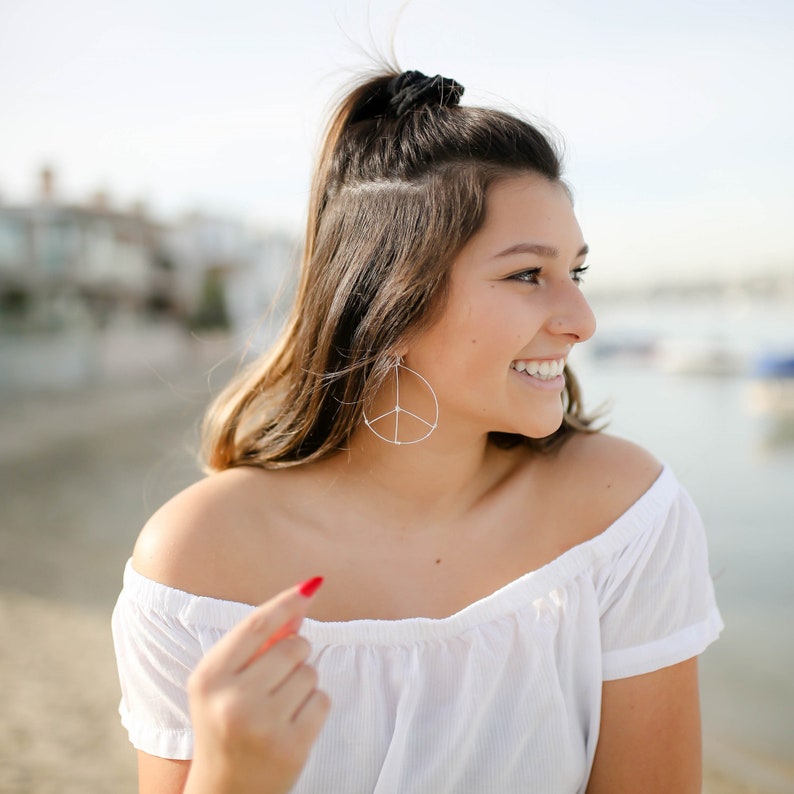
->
[201,576,323,675]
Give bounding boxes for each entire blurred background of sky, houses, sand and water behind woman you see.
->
[0,0,794,794]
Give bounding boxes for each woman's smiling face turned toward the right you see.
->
[404,175,595,438]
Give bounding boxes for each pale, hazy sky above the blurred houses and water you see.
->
[0,0,794,283]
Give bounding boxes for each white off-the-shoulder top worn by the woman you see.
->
[113,468,722,794]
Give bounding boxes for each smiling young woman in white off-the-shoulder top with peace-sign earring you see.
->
[113,72,721,794]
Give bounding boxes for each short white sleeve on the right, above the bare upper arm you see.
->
[596,470,723,681]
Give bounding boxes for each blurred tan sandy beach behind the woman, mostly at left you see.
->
[0,356,791,794]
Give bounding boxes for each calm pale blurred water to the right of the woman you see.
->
[576,292,794,780]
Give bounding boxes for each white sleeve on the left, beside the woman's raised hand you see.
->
[112,562,252,759]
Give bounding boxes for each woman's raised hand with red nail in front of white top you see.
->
[185,579,330,794]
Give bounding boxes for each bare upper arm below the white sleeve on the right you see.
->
[587,658,702,794]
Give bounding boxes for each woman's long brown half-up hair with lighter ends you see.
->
[202,72,589,470]
